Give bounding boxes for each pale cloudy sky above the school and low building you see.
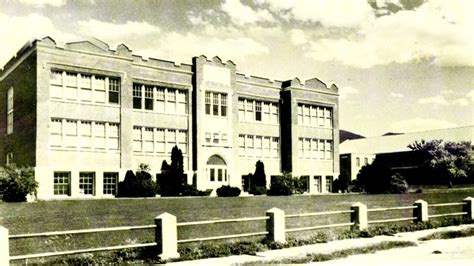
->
[0,0,474,136]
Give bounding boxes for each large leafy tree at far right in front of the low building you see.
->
[408,140,472,184]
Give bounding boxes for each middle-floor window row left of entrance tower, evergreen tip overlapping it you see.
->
[133,126,188,154]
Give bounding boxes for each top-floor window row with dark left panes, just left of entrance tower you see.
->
[133,84,188,114]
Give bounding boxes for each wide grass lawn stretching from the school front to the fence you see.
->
[0,188,474,255]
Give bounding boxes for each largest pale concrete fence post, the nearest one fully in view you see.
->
[155,212,179,260]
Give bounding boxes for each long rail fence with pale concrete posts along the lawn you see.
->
[0,197,474,265]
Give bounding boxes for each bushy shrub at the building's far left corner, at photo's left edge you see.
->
[0,165,38,202]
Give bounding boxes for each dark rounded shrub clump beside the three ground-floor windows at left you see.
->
[117,164,158,198]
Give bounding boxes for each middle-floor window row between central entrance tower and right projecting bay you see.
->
[239,135,280,158]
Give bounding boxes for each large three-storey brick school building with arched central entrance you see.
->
[0,37,339,199]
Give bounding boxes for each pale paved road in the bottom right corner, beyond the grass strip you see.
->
[311,237,474,266]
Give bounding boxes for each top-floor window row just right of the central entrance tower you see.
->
[238,98,279,125]
